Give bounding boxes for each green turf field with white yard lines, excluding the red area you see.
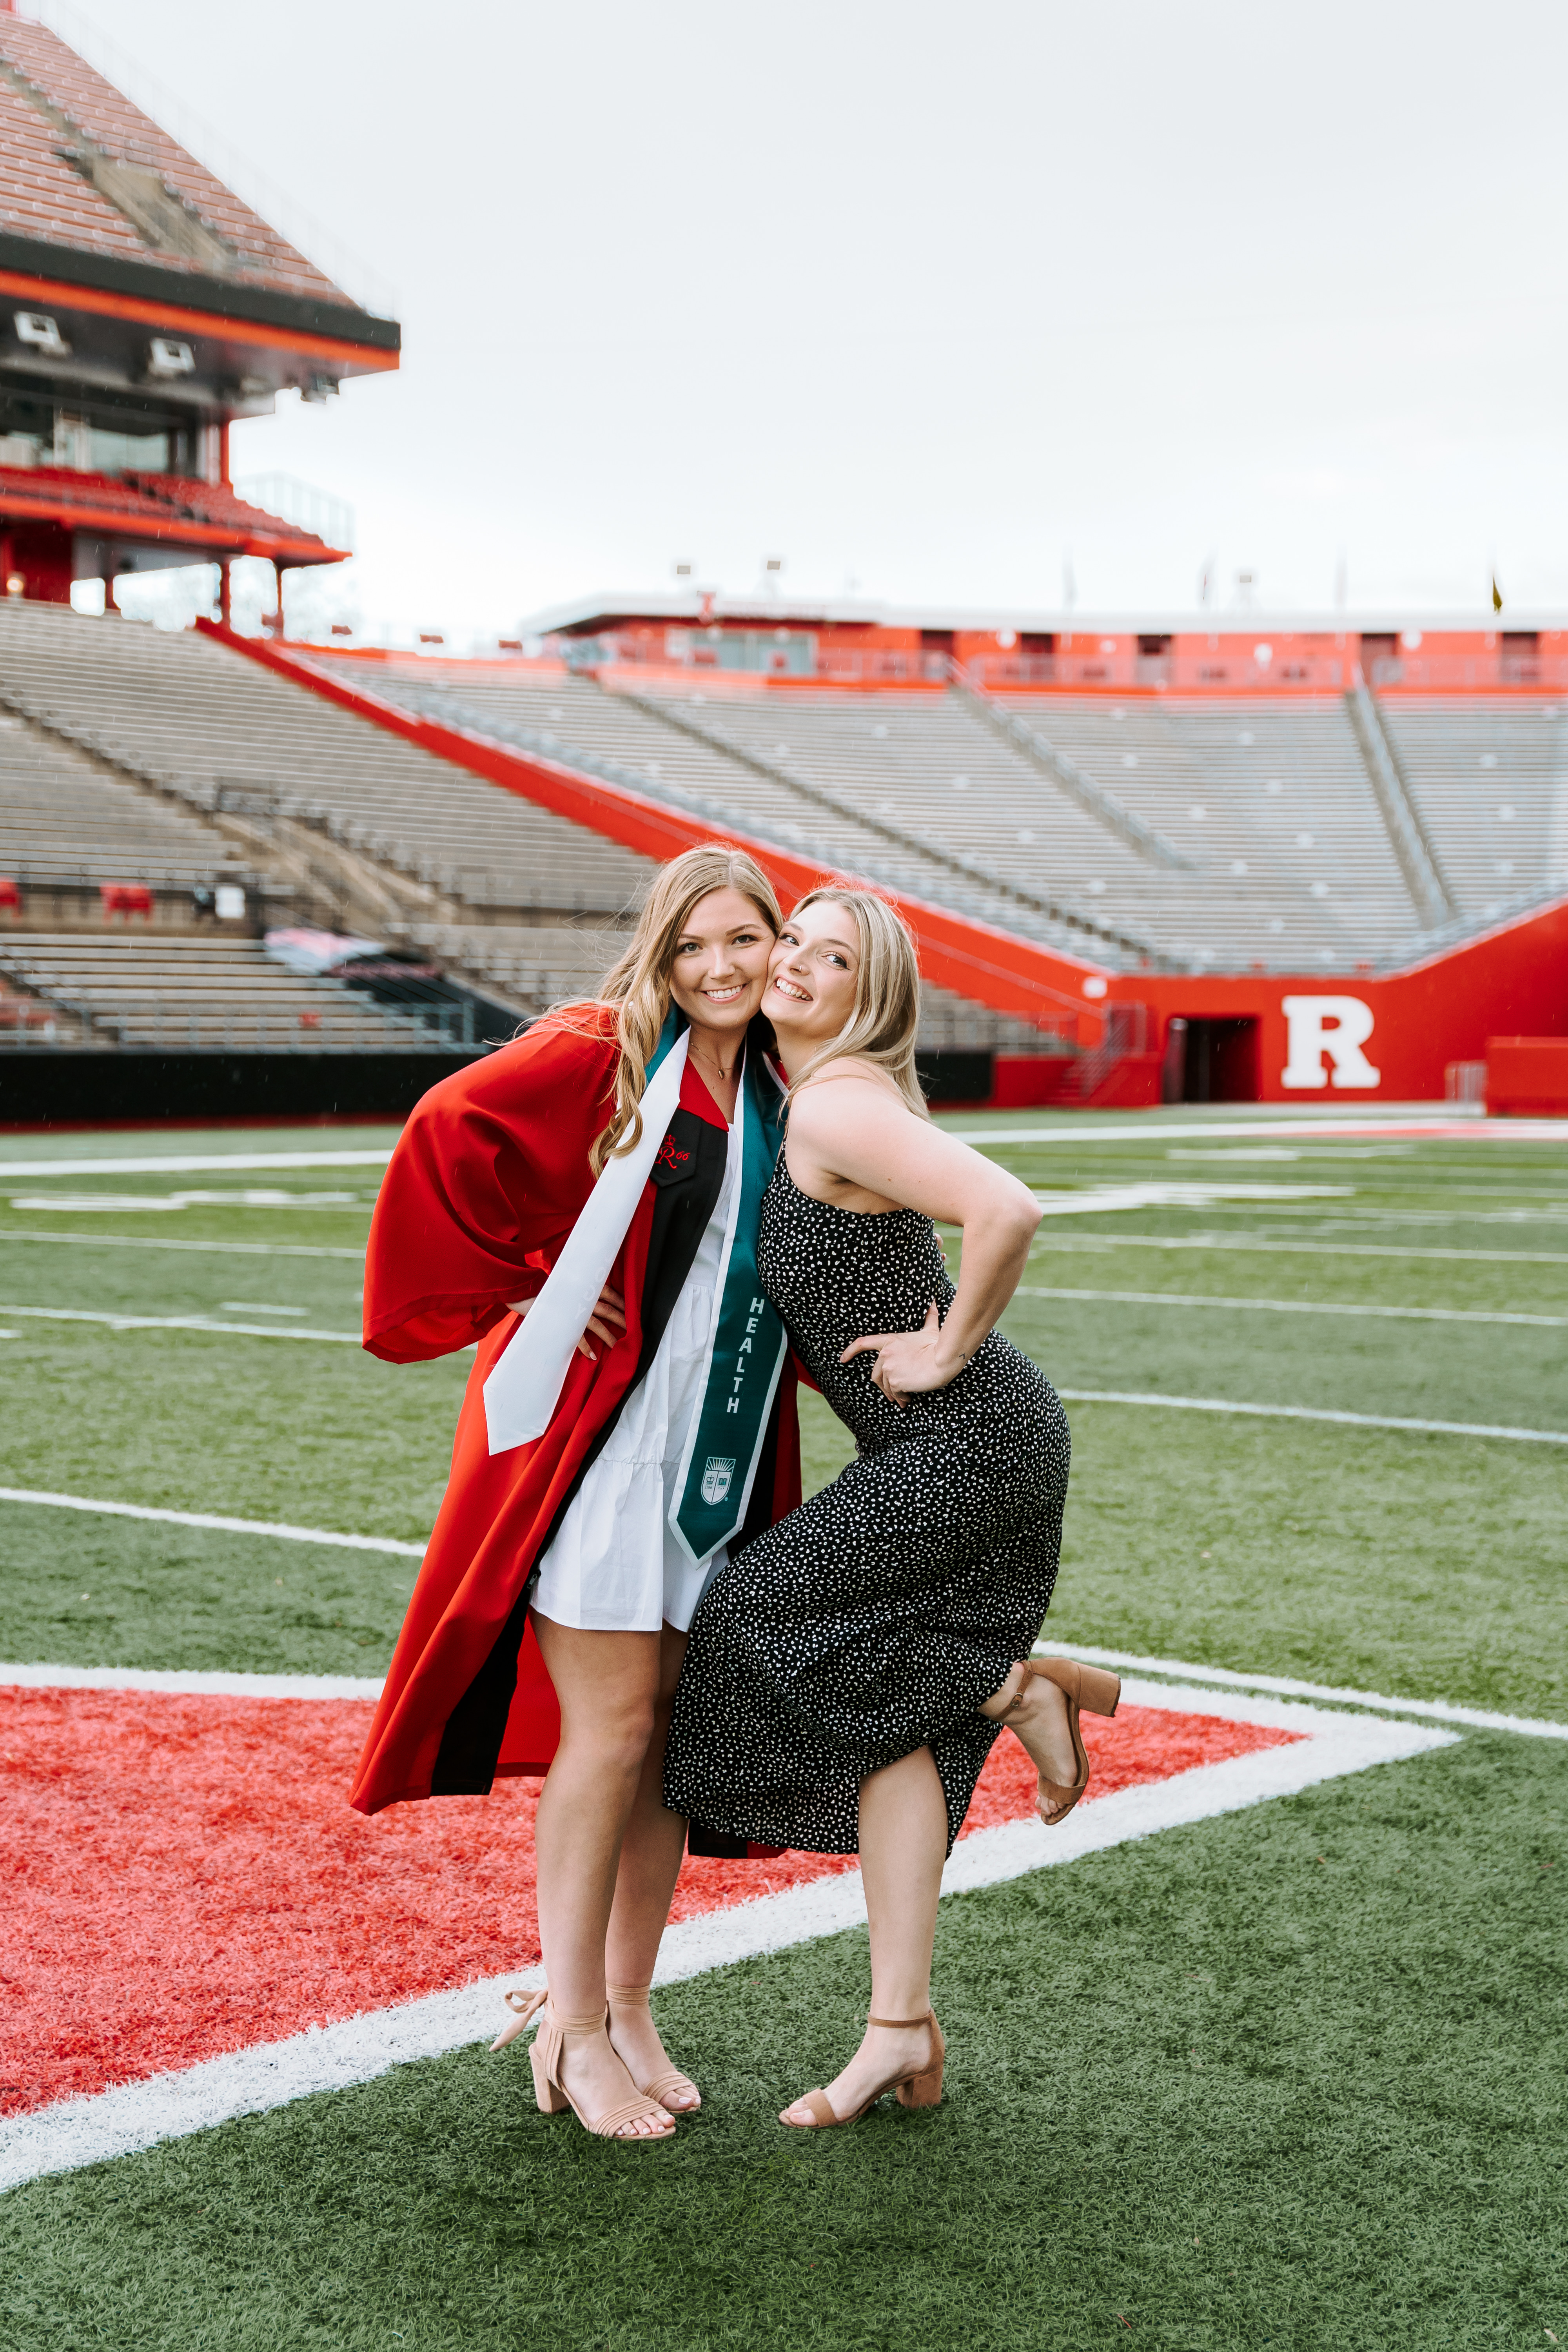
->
[0,1110,1568,2352]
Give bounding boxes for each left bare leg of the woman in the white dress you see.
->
[534,1611,658,2131]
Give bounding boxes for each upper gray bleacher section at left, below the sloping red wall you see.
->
[0,597,651,915]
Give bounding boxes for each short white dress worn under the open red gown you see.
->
[534,1127,738,1632]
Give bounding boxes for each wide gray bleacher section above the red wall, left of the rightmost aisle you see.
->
[364,661,1417,971]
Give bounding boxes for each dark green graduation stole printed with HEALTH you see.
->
[649,1009,788,1559]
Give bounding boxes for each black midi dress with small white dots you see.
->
[665,1152,1070,1853]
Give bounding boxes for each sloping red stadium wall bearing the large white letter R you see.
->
[198,621,1568,1108]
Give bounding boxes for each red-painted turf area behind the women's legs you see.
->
[0,1689,1298,2114]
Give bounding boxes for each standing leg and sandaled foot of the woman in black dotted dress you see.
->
[783,1748,947,2124]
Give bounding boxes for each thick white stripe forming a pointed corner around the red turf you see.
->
[0,1684,1457,2190]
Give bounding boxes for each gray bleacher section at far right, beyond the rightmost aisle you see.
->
[1380,694,1568,917]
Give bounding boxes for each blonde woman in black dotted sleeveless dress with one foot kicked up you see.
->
[665,889,1119,2129]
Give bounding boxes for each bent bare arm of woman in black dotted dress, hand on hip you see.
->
[790,1065,1039,1404]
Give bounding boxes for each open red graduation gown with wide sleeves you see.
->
[350,1009,799,1813]
